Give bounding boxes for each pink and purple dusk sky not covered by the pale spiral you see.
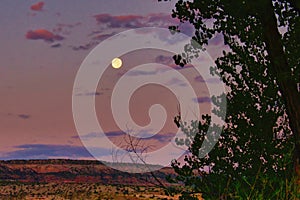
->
[0,0,222,167]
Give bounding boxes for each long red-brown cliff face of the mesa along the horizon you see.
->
[0,159,173,185]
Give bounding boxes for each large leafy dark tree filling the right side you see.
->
[162,0,300,198]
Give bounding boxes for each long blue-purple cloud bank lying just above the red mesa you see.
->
[1,144,103,160]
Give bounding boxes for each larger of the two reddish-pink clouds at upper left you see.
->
[26,29,64,42]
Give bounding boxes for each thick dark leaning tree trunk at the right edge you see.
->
[260,0,300,180]
